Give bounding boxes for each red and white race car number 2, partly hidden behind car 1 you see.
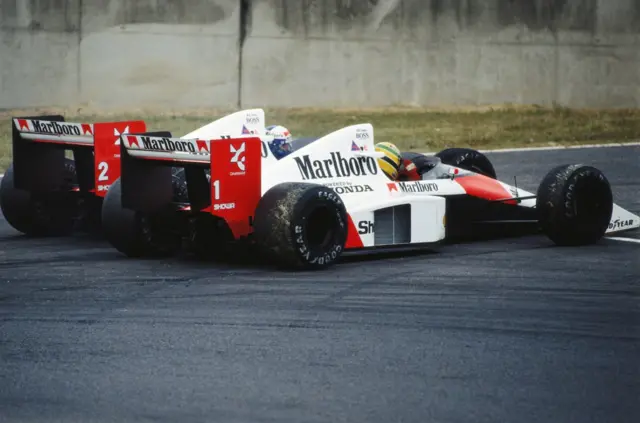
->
[0,110,264,236]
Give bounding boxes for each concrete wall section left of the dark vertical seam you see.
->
[0,0,239,108]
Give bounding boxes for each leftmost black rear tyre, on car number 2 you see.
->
[0,159,80,236]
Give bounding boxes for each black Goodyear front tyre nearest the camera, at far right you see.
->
[536,164,613,246]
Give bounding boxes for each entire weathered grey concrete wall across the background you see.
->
[0,0,640,108]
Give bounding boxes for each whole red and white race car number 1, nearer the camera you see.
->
[102,111,640,269]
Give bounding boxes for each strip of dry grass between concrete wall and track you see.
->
[0,106,640,173]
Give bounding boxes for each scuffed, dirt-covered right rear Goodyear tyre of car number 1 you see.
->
[253,182,349,270]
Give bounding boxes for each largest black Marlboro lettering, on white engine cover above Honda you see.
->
[294,152,378,181]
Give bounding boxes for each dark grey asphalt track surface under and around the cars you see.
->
[0,147,640,423]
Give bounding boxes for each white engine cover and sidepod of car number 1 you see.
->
[262,124,450,247]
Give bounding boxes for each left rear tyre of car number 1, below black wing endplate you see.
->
[102,178,182,258]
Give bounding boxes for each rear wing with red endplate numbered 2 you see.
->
[12,115,146,197]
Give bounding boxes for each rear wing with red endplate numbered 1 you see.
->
[120,132,262,238]
